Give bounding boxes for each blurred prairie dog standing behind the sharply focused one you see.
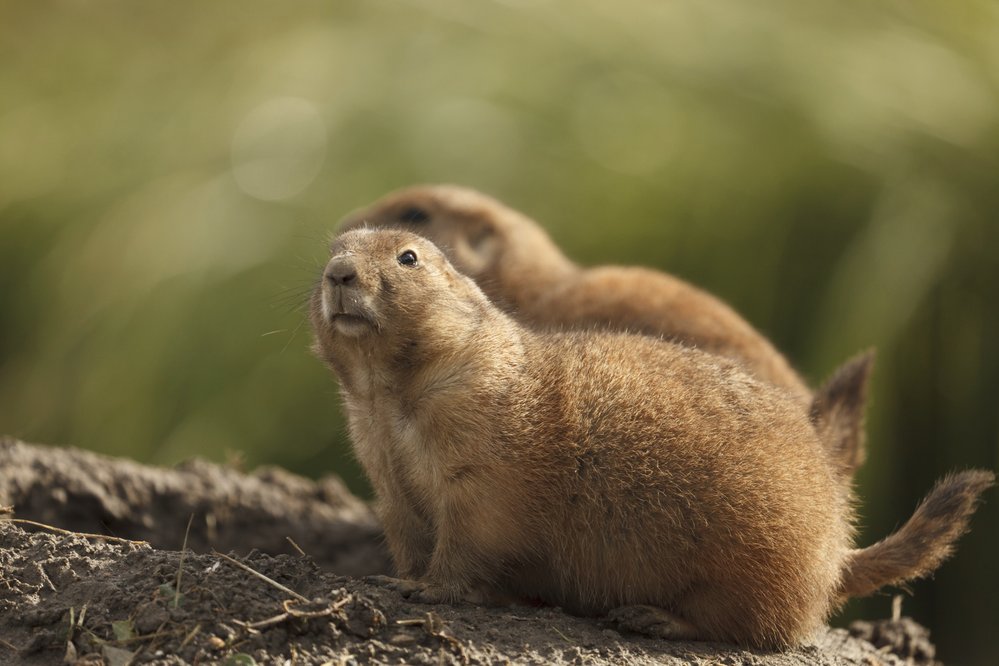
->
[341,185,872,479]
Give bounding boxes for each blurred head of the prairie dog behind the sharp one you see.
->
[341,185,568,286]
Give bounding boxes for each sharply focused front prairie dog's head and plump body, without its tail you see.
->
[311,230,984,647]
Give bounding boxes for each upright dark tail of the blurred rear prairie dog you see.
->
[811,349,874,481]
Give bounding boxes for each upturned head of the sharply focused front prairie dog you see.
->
[311,229,491,358]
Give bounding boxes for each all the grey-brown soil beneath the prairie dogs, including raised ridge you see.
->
[0,439,933,666]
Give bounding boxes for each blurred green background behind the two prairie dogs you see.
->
[0,0,999,664]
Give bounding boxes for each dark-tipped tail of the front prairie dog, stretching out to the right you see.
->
[840,470,995,601]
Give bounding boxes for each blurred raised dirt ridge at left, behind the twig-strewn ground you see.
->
[0,438,390,576]
